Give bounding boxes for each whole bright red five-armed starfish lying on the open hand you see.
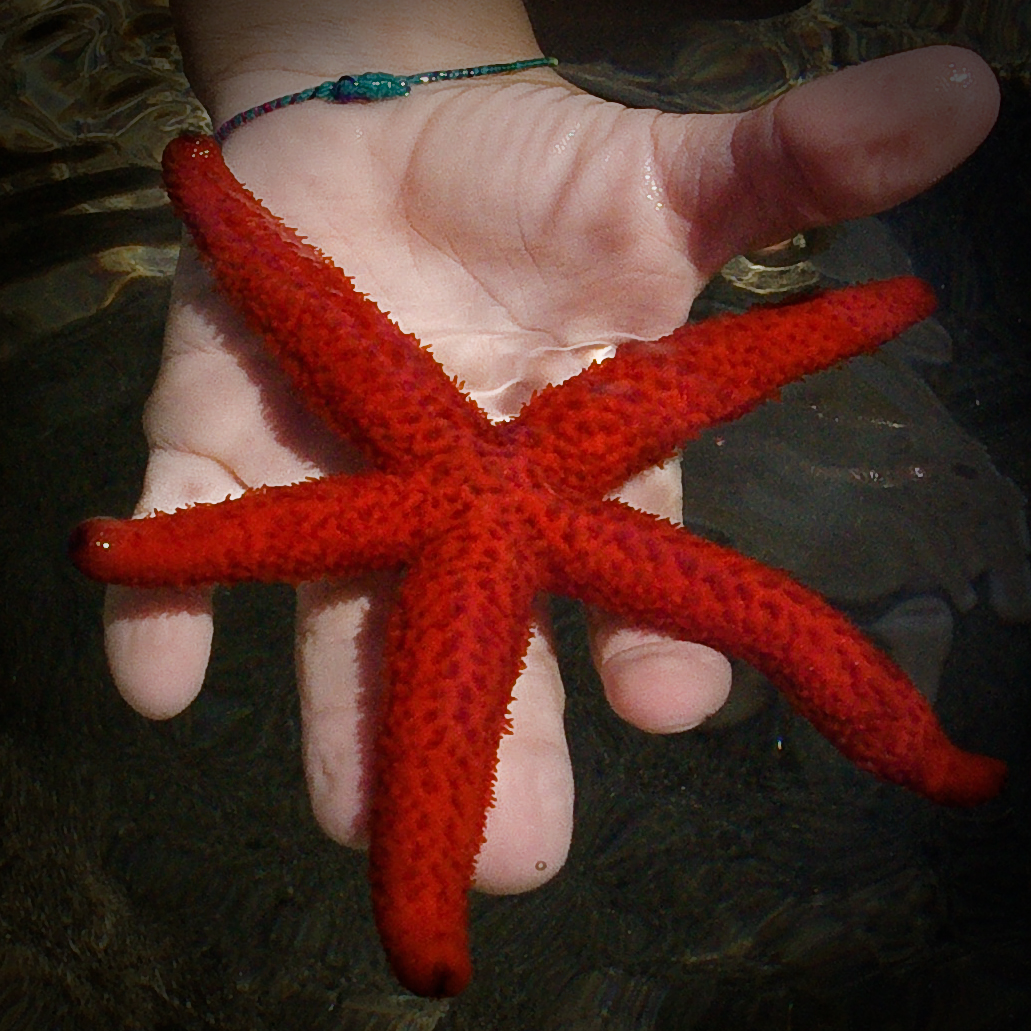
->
[72,137,1004,995]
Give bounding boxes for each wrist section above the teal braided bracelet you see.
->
[171,0,540,125]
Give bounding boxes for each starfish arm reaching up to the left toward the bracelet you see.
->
[164,136,490,464]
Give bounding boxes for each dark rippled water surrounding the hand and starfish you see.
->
[0,0,1031,1031]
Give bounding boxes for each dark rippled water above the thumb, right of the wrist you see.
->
[527,0,1031,111]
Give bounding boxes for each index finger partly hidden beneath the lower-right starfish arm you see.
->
[588,460,730,734]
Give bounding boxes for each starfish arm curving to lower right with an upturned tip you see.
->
[552,501,1005,805]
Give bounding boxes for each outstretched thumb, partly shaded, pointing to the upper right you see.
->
[659,46,999,269]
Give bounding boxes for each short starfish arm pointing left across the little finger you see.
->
[70,473,422,588]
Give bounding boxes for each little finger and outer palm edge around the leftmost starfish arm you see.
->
[105,246,346,719]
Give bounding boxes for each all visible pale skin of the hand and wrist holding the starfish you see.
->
[105,0,998,892]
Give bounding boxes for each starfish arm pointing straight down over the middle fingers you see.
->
[369,512,535,996]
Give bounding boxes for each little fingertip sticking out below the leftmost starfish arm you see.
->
[104,587,212,720]
